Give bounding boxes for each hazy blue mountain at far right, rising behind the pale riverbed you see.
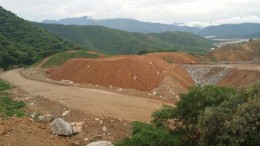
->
[197,23,260,38]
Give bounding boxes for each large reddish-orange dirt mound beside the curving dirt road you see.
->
[46,55,192,91]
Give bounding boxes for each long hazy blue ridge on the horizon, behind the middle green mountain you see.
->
[42,16,200,33]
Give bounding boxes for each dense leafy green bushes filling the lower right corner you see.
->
[116,83,260,146]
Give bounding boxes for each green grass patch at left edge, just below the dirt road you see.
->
[0,79,26,118]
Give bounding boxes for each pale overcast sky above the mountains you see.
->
[0,0,260,26]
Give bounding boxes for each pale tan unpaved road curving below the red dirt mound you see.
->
[0,69,169,122]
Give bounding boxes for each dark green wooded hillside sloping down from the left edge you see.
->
[0,6,79,69]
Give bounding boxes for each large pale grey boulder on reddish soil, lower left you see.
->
[50,118,73,136]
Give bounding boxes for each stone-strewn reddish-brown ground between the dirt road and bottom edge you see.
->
[0,88,131,146]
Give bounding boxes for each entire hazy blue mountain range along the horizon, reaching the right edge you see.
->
[43,16,260,38]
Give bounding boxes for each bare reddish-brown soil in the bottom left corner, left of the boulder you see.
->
[0,118,69,146]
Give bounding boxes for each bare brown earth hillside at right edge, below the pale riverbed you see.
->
[209,40,260,63]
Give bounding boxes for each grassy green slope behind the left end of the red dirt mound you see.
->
[42,50,99,68]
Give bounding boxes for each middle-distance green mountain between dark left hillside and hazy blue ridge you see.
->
[37,24,214,54]
